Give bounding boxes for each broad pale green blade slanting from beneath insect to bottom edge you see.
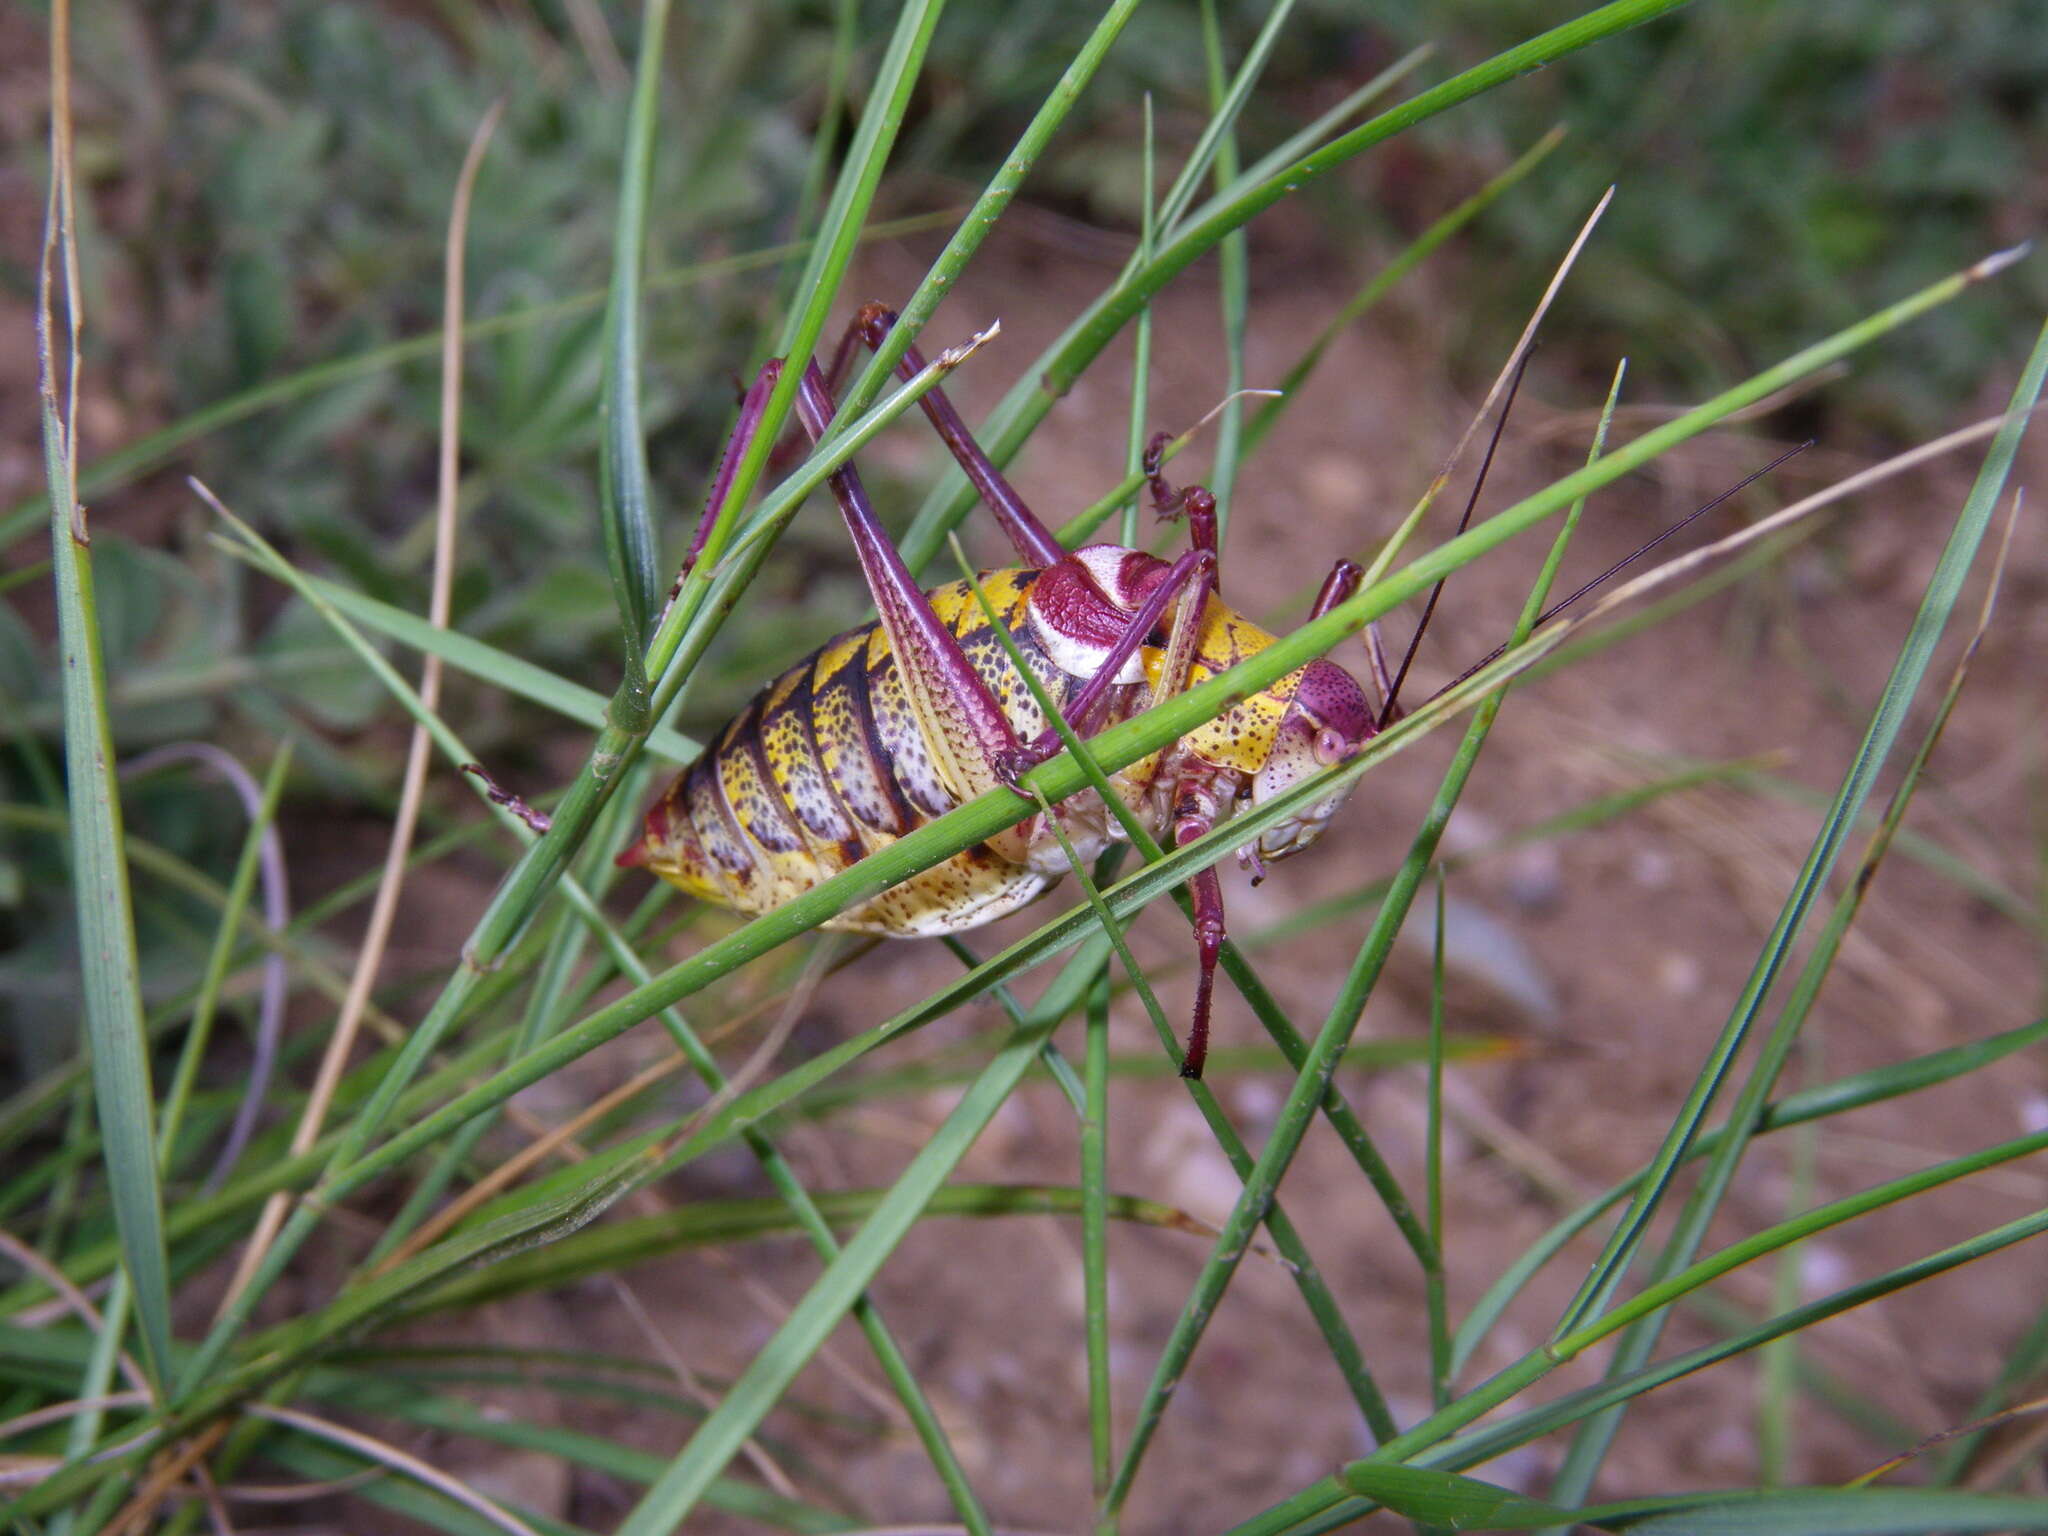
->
[618,938,1108,1536]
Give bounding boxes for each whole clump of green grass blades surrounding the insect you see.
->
[0,0,2048,1536]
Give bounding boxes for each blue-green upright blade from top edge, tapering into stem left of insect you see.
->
[598,0,668,731]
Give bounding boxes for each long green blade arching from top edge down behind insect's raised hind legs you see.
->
[903,0,1686,571]
